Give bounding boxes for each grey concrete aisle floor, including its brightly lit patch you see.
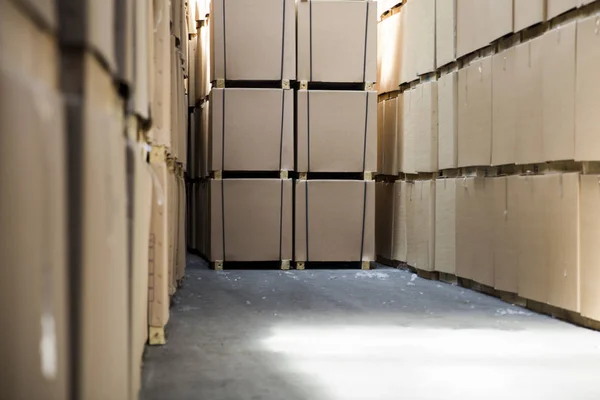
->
[141,256,600,400]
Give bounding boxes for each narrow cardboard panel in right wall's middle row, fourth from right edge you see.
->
[492,47,517,165]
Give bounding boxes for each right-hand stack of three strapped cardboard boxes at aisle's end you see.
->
[295,1,377,269]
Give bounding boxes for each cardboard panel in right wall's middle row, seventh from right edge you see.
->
[411,81,438,172]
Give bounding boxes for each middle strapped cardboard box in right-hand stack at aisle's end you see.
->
[296,90,377,172]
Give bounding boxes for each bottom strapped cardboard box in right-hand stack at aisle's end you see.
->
[295,180,375,262]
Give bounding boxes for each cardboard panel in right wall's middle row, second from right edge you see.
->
[542,22,577,161]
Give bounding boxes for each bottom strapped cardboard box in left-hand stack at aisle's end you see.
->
[207,179,293,262]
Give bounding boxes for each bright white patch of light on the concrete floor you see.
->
[263,326,600,400]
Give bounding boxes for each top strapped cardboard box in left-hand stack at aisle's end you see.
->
[211,0,296,81]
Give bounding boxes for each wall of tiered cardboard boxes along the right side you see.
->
[377,0,600,321]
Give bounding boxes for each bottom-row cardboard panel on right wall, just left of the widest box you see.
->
[456,178,494,286]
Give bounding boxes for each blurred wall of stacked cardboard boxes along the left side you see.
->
[0,0,187,399]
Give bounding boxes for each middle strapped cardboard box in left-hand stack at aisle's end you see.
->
[211,89,296,171]
